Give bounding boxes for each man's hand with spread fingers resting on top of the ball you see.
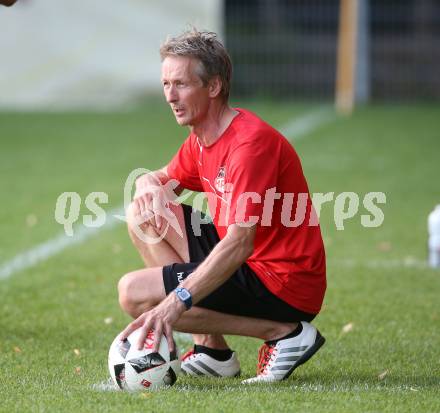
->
[119,293,185,352]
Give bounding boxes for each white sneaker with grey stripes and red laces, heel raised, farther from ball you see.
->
[242,321,325,384]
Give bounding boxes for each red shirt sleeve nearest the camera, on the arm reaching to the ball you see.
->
[227,143,279,225]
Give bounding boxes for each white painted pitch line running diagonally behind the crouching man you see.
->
[0,108,335,281]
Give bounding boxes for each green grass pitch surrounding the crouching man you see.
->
[0,102,440,412]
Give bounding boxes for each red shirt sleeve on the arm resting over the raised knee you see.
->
[167,135,203,192]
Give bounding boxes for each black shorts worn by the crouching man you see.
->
[163,205,316,322]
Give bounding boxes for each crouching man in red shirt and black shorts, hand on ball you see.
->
[119,30,326,383]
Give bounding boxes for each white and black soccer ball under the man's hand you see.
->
[108,329,180,391]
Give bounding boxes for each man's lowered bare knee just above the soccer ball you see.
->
[118,273,156,317]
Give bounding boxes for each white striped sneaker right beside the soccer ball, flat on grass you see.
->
[181,350,240,377]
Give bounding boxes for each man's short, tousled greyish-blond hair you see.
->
[160,28,232,102]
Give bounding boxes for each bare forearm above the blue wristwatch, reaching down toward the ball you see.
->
[181,225,253,304]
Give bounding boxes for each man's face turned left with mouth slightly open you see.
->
[162,56,210,126]
